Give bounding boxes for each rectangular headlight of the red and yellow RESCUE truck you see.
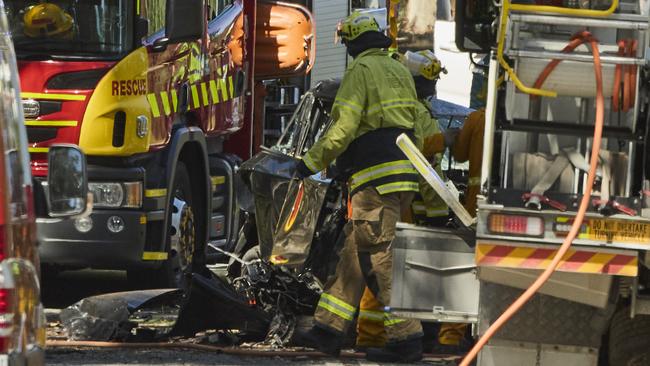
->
[88,182,142,208]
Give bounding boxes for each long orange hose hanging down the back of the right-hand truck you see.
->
[460,36,605,366]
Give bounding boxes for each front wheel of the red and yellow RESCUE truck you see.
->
[129,161,198,288]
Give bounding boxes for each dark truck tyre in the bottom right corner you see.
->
[609,307,650,366]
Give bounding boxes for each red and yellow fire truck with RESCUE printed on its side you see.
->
[5,0,315,287]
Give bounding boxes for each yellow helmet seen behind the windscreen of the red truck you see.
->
[23,3,73,38]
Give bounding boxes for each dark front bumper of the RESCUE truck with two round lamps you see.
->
[36,210,153,269]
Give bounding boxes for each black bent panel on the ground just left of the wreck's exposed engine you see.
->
[170,273,271,339]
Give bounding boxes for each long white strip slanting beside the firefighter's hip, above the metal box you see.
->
[397,134,476,228]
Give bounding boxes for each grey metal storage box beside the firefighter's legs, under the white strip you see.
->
[390,223,479,323]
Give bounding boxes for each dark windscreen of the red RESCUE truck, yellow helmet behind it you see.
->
[5,0,134,58]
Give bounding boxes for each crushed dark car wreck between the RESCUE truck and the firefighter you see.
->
[167,80,471,346]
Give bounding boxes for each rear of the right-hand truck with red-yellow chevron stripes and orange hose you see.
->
[391,0,650,366]
